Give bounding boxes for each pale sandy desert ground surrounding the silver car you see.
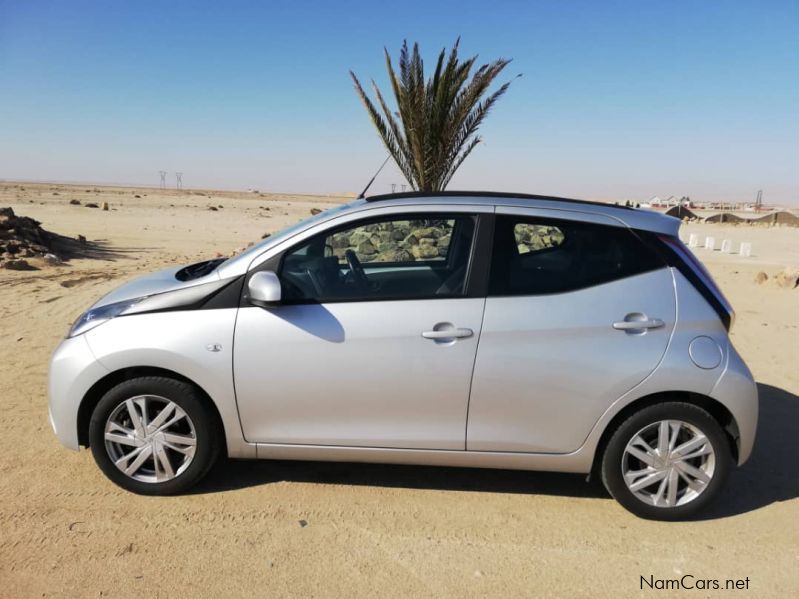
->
[0,184,799,597]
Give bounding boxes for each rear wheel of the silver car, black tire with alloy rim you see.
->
[601,402,732,520]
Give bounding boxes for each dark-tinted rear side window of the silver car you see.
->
[489,215,666,295]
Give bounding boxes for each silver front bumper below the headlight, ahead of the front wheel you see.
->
[48,335,109,450]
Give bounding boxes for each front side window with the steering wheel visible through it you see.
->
[280,214,475,303]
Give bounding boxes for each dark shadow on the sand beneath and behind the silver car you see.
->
[193,383,799,520]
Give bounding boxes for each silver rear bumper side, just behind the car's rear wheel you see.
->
[710,343,759,466]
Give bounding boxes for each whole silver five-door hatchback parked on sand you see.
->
[50,192,758,520]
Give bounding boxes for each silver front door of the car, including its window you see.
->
[234,208,485,450]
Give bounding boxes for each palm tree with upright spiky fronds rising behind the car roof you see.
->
[350,38,510,191]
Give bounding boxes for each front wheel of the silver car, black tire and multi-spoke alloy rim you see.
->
[89,376,222,495]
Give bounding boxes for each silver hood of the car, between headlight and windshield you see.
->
[92,260,222,308]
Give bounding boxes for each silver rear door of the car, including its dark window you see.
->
[467,208,676,453]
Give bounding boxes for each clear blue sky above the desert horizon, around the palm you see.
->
[0,0,799,203]
